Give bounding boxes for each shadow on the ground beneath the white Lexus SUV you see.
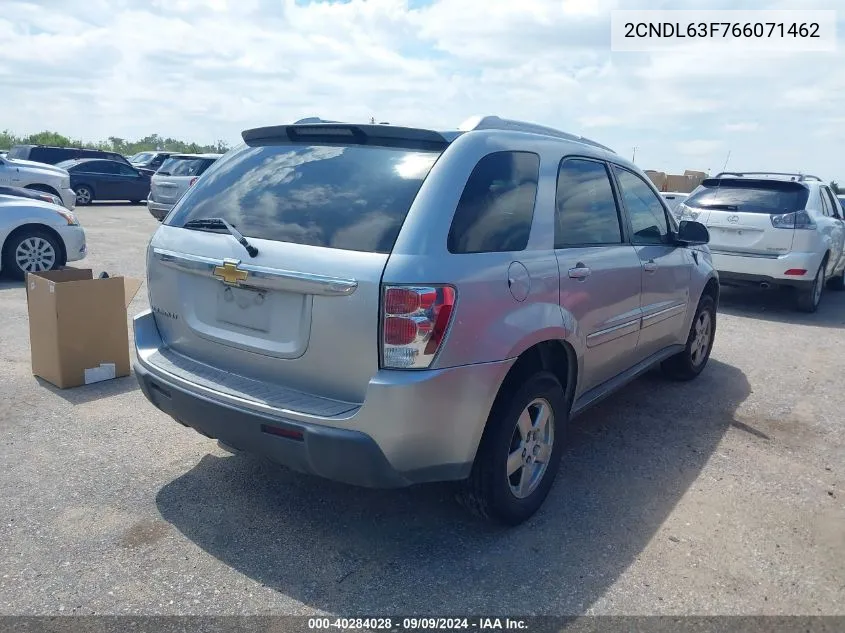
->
[719,286,845,328]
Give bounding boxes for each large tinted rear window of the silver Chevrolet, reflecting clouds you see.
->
[166,143,439,253]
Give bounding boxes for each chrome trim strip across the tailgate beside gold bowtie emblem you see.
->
[153,248,358,296]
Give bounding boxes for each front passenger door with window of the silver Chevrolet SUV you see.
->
[613,165,694,359]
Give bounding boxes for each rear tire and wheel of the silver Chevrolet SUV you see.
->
[458,371,569,525]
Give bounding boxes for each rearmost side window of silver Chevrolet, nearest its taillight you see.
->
[447,152,540,253]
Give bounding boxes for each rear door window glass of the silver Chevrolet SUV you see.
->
[555,158,622,248]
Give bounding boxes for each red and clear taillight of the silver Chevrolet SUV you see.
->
[381,286,455,369]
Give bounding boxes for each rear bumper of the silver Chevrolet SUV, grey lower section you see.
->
[134,312,513,488]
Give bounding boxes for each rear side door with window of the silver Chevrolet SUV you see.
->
[555,158,642,390]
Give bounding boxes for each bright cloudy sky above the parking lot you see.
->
[0,0,845,178]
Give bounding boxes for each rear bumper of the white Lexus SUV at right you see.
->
[711,248,822,288]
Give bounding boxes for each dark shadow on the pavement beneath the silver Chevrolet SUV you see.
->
[157,360,748,615]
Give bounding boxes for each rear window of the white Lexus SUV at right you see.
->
[683,180,810,215]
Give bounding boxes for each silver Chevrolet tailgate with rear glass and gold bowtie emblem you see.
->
[148,136,439,402]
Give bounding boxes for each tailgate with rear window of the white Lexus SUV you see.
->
[683,178,809,258]
